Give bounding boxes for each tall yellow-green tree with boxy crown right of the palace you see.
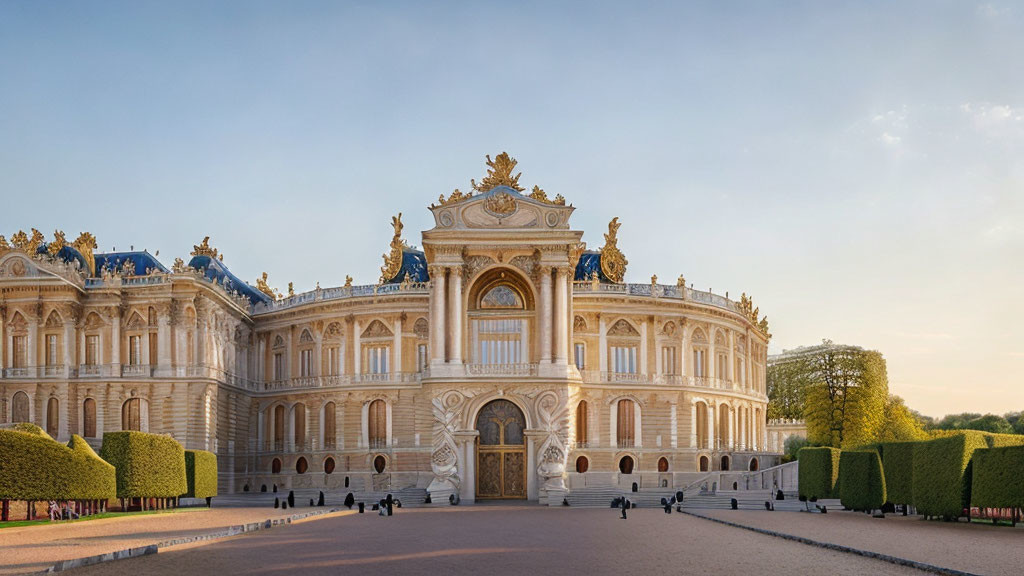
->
[795,340,889,448]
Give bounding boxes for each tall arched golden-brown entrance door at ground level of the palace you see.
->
[476,400,526,498]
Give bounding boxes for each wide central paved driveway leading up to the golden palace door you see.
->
[64,505,922,576]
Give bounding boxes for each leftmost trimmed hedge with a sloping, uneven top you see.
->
[0,423,116,501]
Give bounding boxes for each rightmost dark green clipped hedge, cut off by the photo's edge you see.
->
[971,446,1024,508]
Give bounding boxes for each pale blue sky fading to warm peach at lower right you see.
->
[0,0,1024,416]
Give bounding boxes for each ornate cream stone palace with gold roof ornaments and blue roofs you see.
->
[0,154,777,502]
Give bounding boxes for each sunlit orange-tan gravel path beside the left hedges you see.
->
[0,503,299,574]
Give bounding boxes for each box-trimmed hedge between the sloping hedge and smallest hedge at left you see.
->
[99,431,188,498]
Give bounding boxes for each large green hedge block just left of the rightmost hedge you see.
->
[911,430,993,519]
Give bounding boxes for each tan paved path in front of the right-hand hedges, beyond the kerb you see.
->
[692,510,1024,575]
